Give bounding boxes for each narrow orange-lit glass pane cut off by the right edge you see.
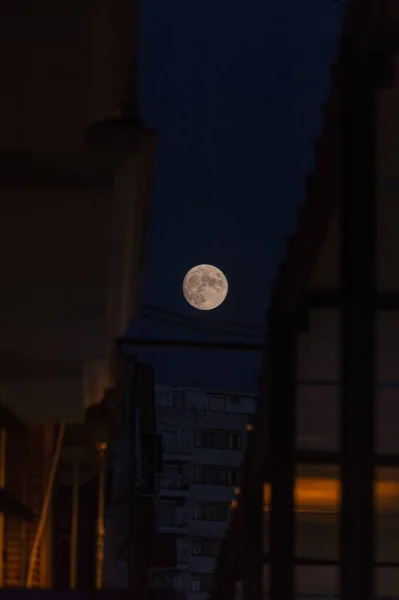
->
[374,467,399,563]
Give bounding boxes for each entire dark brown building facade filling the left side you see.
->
[0,0,155,588]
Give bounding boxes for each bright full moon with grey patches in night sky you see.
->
[183,265,229,310]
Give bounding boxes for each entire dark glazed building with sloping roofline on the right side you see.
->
[212,0,399,600]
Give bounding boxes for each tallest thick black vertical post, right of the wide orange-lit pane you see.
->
[340,38,377,600]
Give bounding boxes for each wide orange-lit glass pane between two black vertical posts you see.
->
[295,465,341,561]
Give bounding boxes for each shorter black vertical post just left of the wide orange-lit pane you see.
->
[268,310,297,600]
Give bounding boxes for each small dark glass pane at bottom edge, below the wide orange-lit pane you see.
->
[295,566,339,598]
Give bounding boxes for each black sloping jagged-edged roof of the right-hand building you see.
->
[272,0,399,312]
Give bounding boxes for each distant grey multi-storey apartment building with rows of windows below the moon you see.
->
[153,386,256,600]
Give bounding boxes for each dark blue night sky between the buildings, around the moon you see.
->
[130,0,343,391]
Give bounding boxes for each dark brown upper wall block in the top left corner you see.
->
[0,0,138,151]
